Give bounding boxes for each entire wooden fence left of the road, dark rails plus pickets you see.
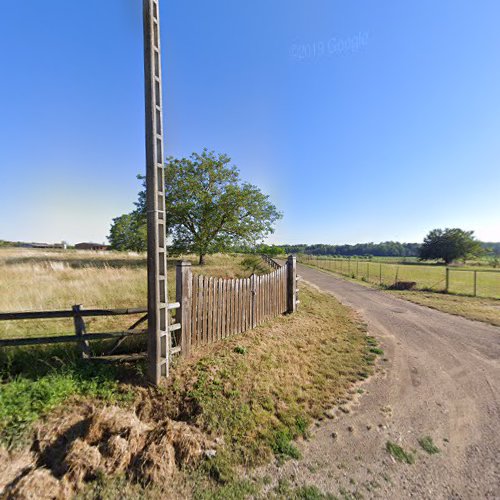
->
[0,256,299,366]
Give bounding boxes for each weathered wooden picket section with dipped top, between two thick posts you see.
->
[176,256,298,355]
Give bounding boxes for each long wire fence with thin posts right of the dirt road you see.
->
[298,255,500,299]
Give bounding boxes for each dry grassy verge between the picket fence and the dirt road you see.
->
[160,286,376,489]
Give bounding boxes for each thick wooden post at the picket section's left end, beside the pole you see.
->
[175,260,193,357]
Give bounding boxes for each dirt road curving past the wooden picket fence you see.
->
[267,266,500,499]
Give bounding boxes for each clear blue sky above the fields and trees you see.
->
[0,0,500,244]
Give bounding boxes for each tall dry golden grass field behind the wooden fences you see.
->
[0,248,256,338]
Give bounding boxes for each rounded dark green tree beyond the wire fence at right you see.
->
[419,228,483,264]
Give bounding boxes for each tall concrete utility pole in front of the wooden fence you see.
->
[143,0,171,384]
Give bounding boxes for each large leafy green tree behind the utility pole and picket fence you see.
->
[109,150,282,264]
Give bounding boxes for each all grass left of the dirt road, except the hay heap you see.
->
[0,250,377,499]
